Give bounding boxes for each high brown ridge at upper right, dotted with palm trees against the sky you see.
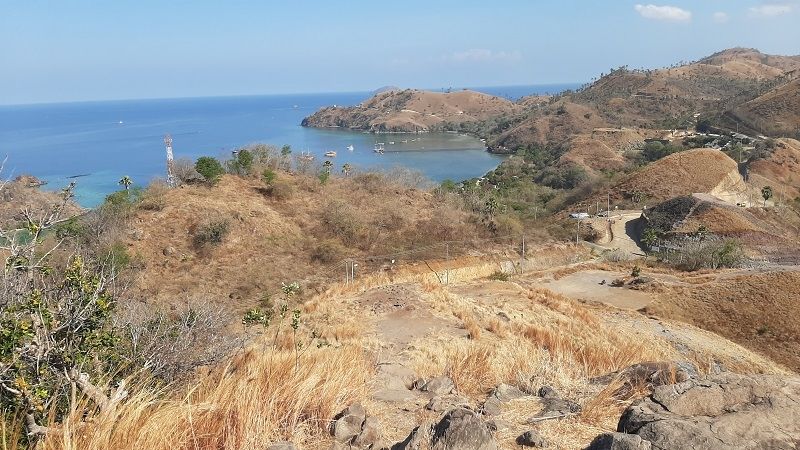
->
[488,48,800,151]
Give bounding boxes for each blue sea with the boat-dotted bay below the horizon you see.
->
[0,84,577,207]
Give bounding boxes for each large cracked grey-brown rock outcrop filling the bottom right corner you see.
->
[590,373,800,450]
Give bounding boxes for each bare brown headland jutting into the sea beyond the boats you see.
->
[302,89,520,132]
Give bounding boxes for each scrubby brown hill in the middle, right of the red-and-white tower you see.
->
[117,172,480,309]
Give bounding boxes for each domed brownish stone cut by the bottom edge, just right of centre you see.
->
[431,408,497,450]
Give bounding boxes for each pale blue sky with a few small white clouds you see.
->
[0,0,800,104]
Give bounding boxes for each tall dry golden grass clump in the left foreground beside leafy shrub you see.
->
[43,346,372,450]
